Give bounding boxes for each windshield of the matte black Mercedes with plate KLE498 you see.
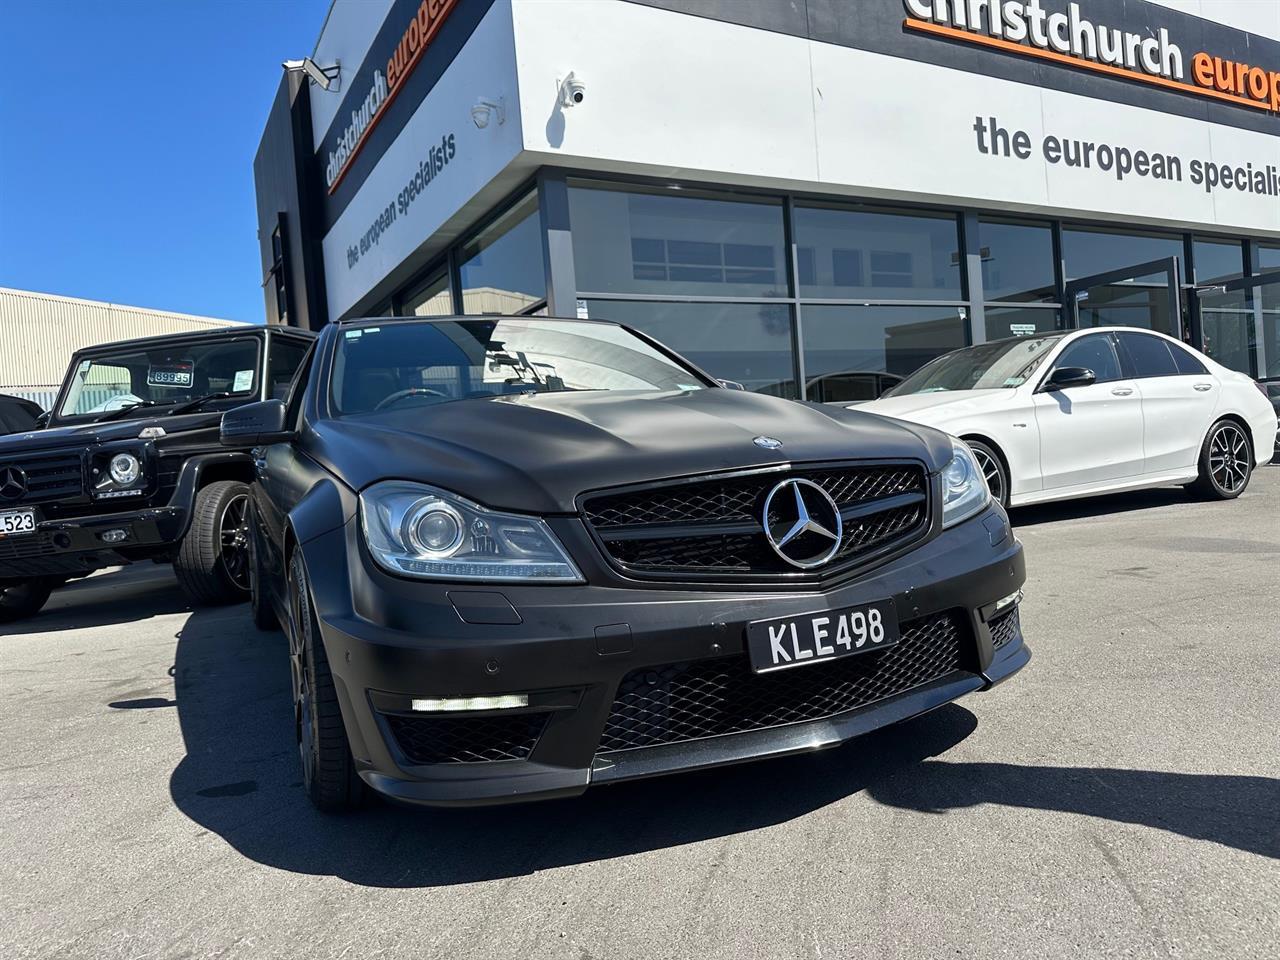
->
[333,317,708,415]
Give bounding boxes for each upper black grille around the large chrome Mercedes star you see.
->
[582,463,929,580]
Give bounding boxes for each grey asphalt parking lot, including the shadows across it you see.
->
[0,467,1280,960]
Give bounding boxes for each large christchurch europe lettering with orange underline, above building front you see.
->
[904,0,1280,113]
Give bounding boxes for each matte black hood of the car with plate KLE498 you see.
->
[305,389,951,513]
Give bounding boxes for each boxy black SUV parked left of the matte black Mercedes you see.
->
[0,326,315,622]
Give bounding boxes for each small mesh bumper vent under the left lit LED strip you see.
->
[387,713,547,763]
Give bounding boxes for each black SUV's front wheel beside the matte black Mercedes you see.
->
[173,480,250,605]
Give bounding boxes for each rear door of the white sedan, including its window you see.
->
[1116,330,1222,475]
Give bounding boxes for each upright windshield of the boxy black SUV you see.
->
[58,337,259,419]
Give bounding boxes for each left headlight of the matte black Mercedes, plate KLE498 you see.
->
[360,480,582,584]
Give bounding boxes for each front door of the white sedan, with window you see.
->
[1033,333,1143,492]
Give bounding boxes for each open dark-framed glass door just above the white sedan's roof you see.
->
[1066,257,1183,339]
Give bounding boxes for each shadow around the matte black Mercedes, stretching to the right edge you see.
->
[172,611,1280,887]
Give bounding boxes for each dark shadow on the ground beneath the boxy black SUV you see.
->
[0,562,191,636]
